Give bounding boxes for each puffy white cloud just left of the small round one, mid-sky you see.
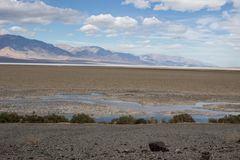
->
[80,14,138,36]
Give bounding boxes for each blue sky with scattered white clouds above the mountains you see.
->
[0,0,240,67]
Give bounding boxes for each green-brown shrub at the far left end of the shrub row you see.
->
[0,112,23,123]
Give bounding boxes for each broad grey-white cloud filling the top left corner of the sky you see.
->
[0,0,81,24]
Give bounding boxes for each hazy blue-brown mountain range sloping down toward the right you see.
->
[0,34,212,67]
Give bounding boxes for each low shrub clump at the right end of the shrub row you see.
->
[208,114,240,123]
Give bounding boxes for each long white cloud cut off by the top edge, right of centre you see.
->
[122,0,240,12]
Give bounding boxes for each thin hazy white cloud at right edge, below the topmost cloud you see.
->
[192,11,240,51]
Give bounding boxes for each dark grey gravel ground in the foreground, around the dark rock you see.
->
[0,124,240,160]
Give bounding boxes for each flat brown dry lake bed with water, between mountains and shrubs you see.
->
[0,65,240,122]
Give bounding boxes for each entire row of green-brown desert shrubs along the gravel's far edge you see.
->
[0,112,240,124]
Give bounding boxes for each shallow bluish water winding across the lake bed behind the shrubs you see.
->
[0,93,240,123]
